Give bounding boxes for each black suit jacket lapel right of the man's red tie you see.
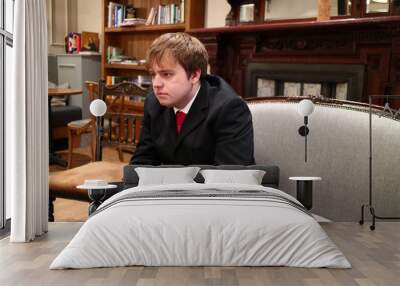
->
[174,81,208,149]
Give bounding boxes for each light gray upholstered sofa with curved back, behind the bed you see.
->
[249,99,400,221]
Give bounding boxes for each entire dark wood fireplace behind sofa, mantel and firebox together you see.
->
[189,16,400,108]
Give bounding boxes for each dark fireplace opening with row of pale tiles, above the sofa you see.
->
[245,63,365,102]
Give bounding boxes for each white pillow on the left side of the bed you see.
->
[135,167,200,186]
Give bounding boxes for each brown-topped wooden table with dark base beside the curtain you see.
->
[48,87,82,167]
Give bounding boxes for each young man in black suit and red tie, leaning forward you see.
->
[130,33,254,165]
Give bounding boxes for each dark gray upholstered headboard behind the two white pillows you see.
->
[123,165,279,189]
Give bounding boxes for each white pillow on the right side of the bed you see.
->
[200,169,265,185]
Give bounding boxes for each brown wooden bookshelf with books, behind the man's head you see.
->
[101,0,205,80]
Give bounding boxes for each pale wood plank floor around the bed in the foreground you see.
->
[0,222,400,286]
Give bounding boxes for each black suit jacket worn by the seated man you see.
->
[130,75,255,165]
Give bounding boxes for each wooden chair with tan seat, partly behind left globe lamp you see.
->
[67,81,99,169]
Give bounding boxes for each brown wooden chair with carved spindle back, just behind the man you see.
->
[99,81,148,162]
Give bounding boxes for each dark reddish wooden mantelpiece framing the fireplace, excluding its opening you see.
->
[188,16,400,106]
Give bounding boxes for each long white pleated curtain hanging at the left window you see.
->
[6,0,49,242]
